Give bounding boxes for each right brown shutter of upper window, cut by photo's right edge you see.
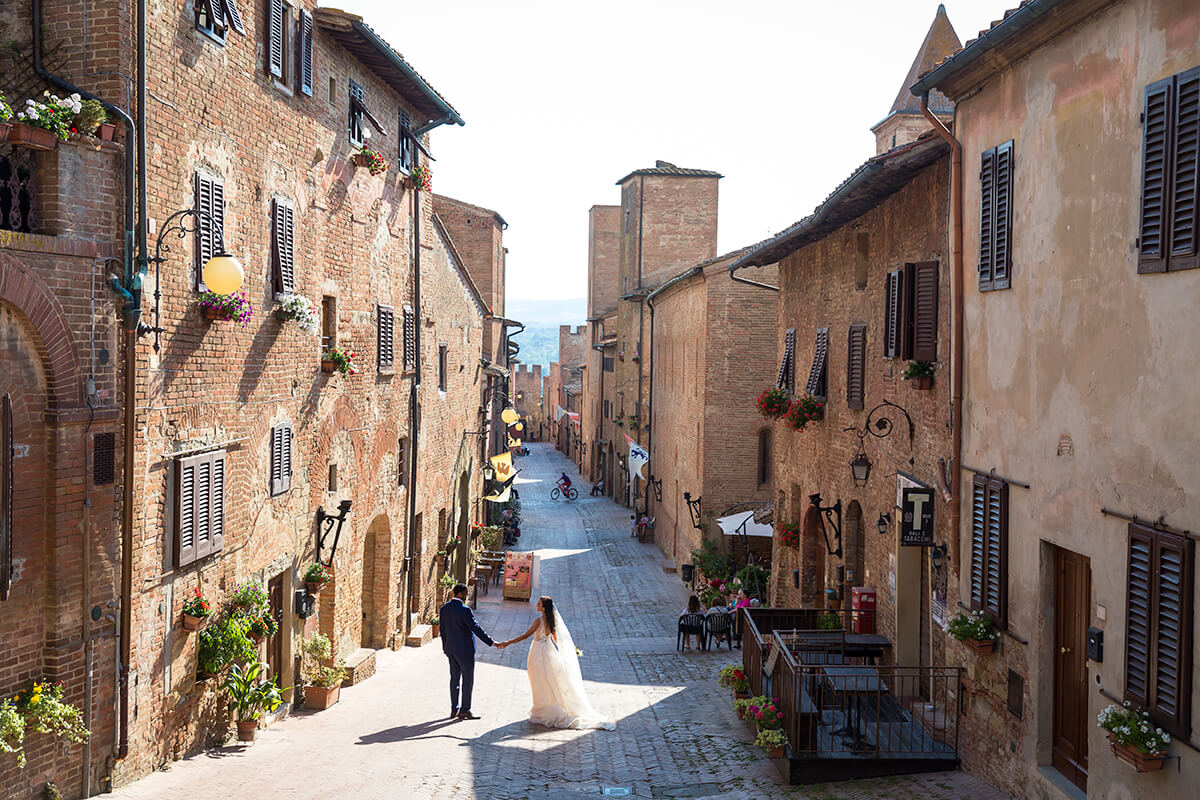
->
[1168,67,1200,271]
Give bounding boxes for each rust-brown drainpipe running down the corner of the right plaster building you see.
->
[920,91,964,569]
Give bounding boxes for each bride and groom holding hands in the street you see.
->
[440,583,617,730]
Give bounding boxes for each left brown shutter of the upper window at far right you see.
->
[1138,78,1174,272]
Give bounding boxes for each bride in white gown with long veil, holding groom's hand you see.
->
[500,596,617,730]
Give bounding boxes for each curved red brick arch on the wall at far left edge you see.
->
[0,253,83,410]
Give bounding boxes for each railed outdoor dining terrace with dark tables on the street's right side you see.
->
[743,608,962,783]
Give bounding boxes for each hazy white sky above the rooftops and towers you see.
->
[338,0,1018,303]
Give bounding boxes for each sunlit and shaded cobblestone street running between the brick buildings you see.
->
[109,444,1004,800]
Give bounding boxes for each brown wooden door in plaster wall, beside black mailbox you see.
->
[1054,548,1092,792]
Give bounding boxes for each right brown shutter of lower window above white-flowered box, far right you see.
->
[1151,531,1195,736]
